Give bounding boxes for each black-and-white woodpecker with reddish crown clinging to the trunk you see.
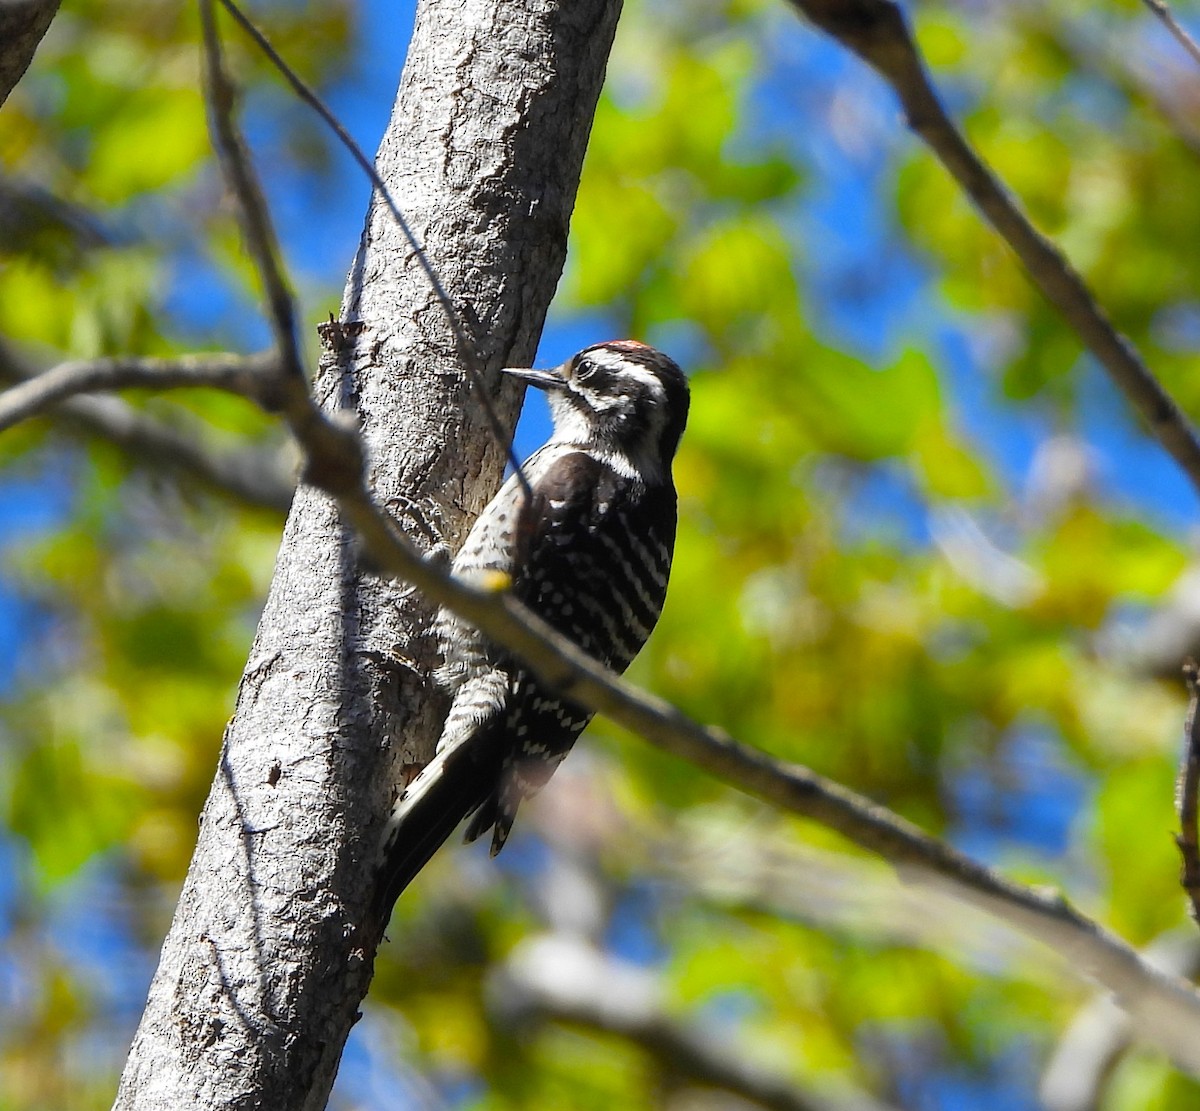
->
[377,340,689,914]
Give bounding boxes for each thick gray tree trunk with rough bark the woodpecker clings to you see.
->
[115,0,619,1111]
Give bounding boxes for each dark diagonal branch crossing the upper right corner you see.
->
[790,0,1200,493]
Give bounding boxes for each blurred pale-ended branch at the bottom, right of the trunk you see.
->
[490,935,890,1111]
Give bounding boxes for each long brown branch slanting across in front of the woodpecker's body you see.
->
[200,0,1200,1074]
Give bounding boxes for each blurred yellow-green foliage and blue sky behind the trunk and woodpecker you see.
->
[0,0,1200,1111]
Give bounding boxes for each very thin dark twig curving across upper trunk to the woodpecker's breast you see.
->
[213,0,533,500]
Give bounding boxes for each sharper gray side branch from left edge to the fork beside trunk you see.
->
[0,353,278,432]
